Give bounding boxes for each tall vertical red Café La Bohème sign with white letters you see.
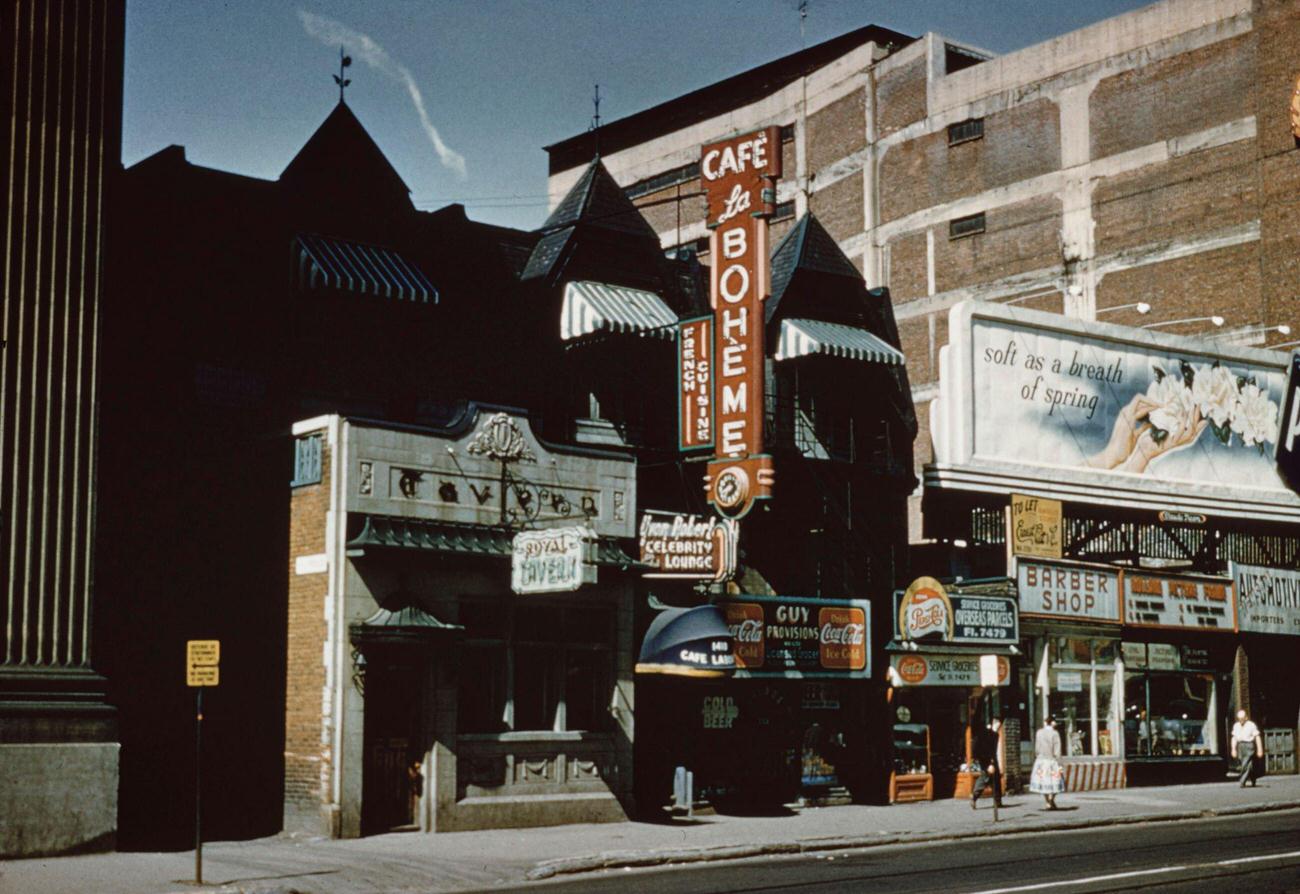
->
[680,127,781,518]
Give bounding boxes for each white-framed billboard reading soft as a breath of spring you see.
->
[926,301,1300,521]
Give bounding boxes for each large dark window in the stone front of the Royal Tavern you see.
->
[459,600,614,733]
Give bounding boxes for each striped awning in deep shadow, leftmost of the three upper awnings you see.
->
[294,235,438,304]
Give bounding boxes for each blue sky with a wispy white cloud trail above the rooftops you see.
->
[122,0,1145,229]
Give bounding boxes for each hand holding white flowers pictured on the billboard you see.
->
[1084,360,1278,473]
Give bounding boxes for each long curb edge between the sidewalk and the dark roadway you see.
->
[524,800,1300,881]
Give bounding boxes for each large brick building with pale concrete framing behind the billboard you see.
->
[547,0,1300,541]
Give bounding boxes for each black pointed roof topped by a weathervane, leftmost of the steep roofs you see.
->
[280,103,411,204]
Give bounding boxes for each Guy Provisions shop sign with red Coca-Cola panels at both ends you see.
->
[722,595,871,678]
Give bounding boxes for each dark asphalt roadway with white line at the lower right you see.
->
[512,812,1300,894]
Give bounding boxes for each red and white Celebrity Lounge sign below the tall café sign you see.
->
[641,509,737,581]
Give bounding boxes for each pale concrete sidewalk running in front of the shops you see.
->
[0,776,1300,894]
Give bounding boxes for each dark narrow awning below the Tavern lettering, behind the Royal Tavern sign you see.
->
[347,513,640,569]
